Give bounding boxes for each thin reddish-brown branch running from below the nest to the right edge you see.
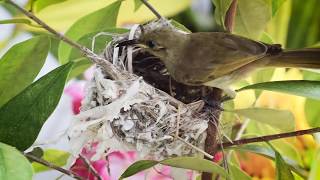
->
[222,127,320,148]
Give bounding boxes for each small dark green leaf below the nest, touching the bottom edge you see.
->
[119,160,159,179]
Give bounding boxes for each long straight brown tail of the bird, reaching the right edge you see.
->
[268,48,320,69]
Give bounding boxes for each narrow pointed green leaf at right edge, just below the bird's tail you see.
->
[237,80,320,100]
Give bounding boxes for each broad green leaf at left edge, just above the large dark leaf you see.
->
[0,36,50,107]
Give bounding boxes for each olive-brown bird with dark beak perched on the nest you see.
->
[128,26,320,98]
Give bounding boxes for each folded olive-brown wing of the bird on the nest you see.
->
[184,32,268,79]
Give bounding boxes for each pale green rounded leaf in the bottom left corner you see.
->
[0,143,33,180]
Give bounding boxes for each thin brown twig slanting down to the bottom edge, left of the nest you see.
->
[24,153,83,180]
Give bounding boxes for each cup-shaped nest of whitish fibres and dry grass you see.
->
[68,20,218,159]
